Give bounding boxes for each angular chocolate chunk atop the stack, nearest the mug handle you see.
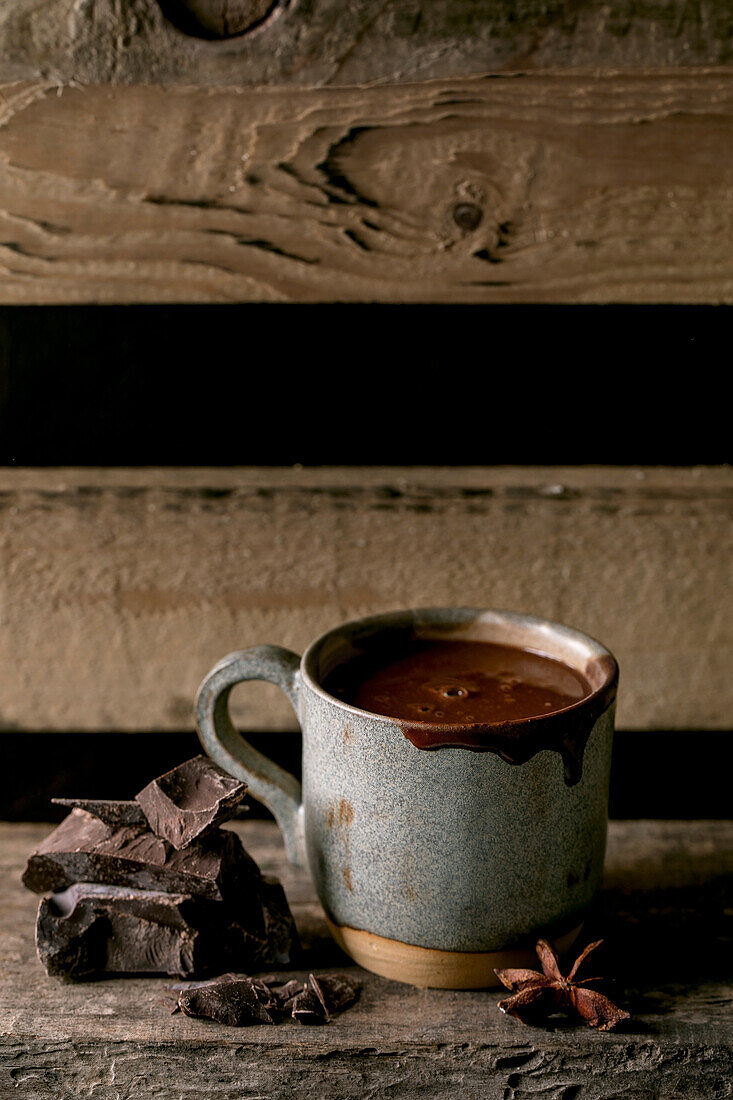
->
[135,756,247,848]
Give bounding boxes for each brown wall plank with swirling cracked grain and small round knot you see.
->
[0,69,733,303]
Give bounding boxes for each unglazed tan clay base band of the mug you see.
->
[327,919,582,989]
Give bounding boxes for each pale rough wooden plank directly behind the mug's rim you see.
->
[0,468,733,730]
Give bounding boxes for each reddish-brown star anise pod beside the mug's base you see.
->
[494,939,628,1031]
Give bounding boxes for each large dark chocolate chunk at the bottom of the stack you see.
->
[36,882,263,979]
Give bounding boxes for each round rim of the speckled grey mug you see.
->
[300,607,619,734]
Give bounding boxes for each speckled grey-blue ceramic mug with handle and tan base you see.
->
[196,608,617,989]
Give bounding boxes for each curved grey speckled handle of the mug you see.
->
[194,646,307,868]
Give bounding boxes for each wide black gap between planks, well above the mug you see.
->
[0,303,733,466]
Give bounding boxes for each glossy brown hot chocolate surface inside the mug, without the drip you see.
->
[347,639,591,725]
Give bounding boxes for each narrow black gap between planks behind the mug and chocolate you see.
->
[0,729,733,821]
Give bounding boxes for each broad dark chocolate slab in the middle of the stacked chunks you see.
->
[23,809,261,902]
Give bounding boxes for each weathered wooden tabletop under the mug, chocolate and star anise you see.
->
[0,822,733,1100]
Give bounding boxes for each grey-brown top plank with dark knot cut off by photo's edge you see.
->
[0,0,733,85]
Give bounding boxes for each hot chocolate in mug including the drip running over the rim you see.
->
[329,638,617,787]
